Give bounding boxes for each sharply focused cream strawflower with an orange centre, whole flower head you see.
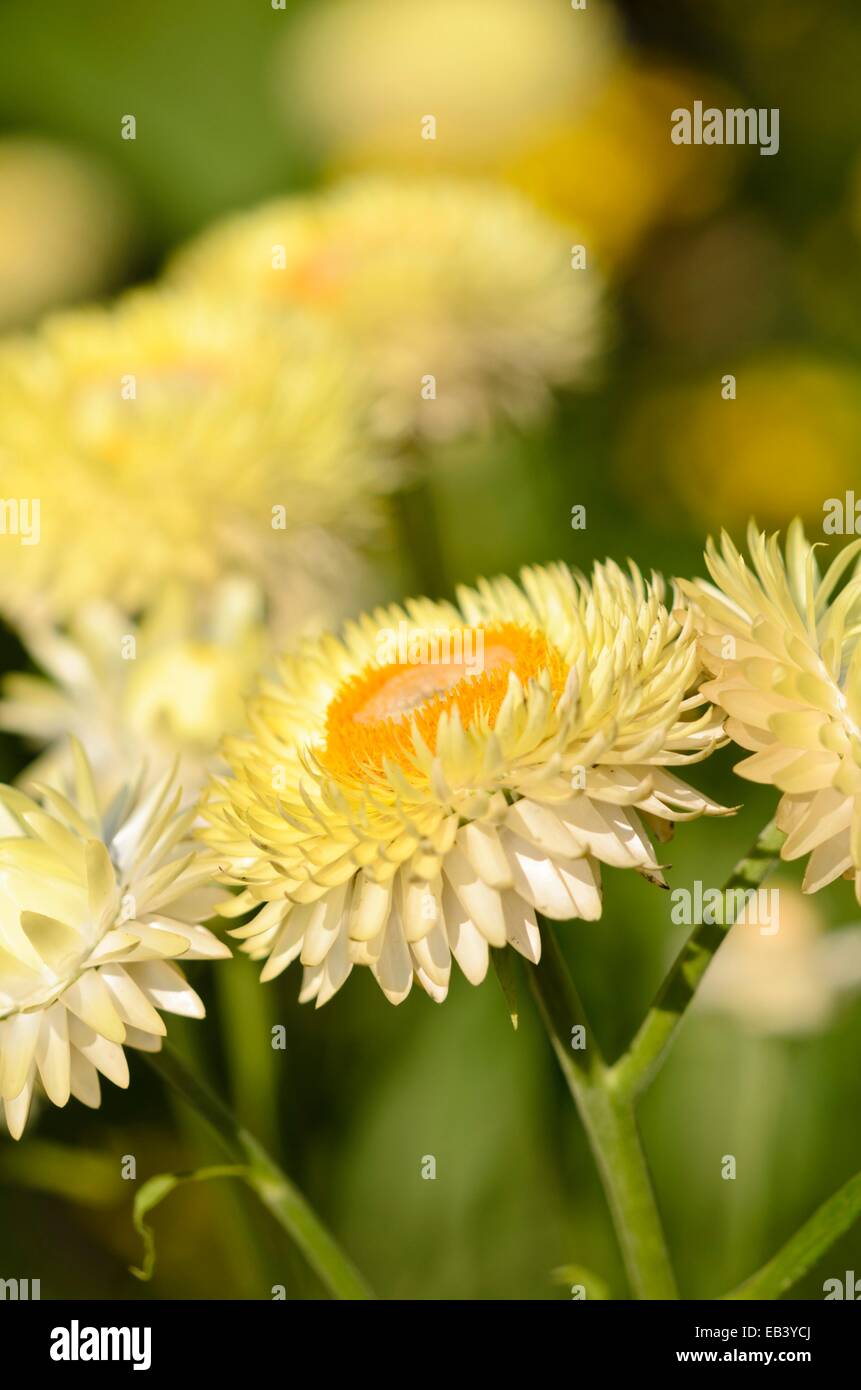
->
[203,563,723,1005]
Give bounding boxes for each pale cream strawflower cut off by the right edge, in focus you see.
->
[682,520,861,902]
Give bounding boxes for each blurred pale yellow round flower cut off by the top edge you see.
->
[275,0,618,174]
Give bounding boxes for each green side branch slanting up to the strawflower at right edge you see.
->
[612,820,784,1097]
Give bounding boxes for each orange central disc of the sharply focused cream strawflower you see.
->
[320,623,568,780]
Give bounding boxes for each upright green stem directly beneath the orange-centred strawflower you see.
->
[530,923,679,1298]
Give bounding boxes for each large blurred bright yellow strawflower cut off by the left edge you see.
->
[0,291,384,624]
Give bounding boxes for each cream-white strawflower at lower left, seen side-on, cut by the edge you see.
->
[0,745,230,1138]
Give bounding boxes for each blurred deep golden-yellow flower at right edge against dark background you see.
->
[619,349,861,527]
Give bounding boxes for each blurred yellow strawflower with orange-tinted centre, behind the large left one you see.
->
[174,178,600,438]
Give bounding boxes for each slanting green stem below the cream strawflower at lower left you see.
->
[142,1044,373,1300]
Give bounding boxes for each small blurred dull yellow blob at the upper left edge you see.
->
[0,136,132,329]
